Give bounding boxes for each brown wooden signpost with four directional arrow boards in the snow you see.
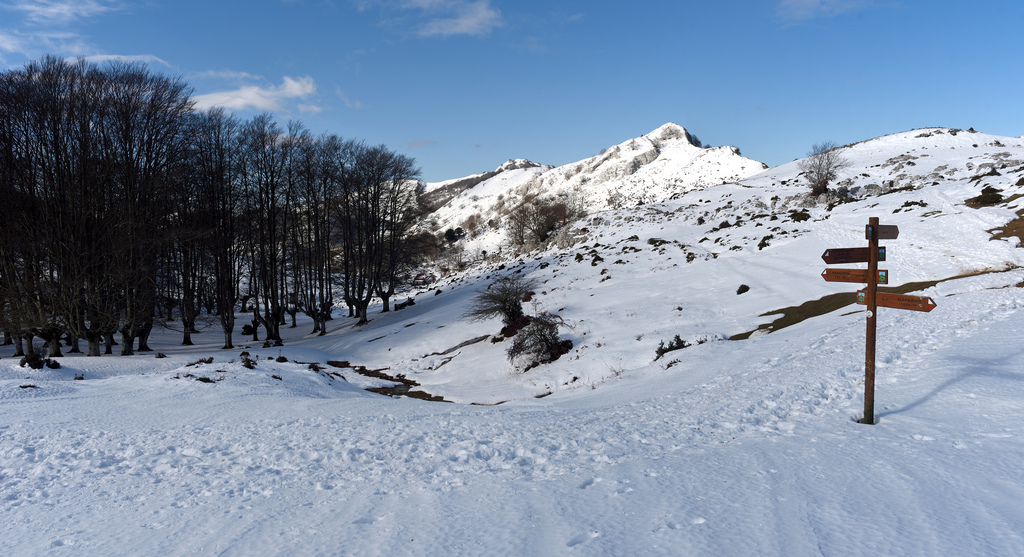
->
[821,217,935,424]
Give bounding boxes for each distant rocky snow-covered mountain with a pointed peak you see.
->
[426,123,767,253]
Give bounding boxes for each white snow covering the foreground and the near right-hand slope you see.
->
[0,129,1024,556]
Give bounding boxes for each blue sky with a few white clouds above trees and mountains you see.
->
[0,0,1024,181]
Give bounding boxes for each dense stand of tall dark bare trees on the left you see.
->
[0,57,419,356]
